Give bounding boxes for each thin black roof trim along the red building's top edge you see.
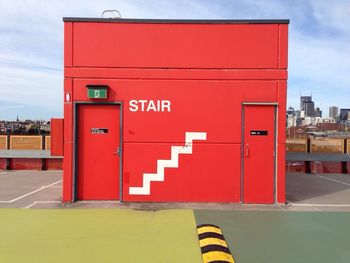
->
[63,17,289,24]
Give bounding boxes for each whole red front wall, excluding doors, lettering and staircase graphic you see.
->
[63,18,288,203]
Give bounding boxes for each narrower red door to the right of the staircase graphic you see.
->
[243,105,275,204]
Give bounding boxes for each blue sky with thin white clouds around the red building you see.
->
[0,0,350,120]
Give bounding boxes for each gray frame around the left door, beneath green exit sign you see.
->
[72,101,123,202]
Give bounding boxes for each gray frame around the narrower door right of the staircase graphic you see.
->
[240,102,278,204]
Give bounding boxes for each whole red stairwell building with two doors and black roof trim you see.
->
[58,18,289,203]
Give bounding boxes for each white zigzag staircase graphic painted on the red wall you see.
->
[129,132,207,195]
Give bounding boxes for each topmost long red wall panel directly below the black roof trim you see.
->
[73,22,279,69]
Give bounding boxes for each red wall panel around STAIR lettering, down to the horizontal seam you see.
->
[73,79,277,143]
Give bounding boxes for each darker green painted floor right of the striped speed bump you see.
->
[195,210,350,263]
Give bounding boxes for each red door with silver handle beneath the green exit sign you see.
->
[77,105,120,200]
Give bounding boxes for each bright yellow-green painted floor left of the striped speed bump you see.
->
[0,209,201,263]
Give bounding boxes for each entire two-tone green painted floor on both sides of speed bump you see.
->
[0,208,350,263]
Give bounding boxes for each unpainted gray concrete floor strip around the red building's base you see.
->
[0,171,350,211]
